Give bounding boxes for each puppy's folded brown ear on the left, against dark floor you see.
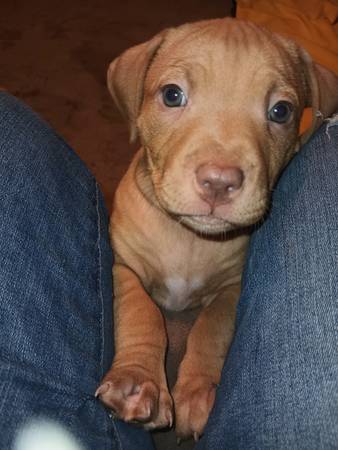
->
[107,30,167,142]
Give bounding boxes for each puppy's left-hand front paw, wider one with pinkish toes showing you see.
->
[95,367,173,429]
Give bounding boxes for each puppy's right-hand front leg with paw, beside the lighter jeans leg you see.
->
[173,285,240,440]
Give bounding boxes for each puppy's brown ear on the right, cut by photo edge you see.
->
[300,50,338,145]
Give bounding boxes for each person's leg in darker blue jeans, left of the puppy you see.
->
[0,93,152,450]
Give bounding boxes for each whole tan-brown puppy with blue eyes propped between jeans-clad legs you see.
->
[97,18,338,438]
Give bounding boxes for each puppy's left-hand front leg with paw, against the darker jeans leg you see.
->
[96,264,173,429]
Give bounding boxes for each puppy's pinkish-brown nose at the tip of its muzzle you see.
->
[196,164,244,205]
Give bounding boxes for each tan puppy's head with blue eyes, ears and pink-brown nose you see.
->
[108,19,337,234]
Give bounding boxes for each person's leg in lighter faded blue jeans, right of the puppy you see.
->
[197,119,338,450]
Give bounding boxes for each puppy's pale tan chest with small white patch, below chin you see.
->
[143,230,243,311]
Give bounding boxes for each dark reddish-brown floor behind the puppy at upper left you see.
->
[0,0,231,211]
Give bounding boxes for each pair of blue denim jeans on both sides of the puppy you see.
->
[0,93,338,450]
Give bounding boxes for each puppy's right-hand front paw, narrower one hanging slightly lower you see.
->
[173,376,216,441]
